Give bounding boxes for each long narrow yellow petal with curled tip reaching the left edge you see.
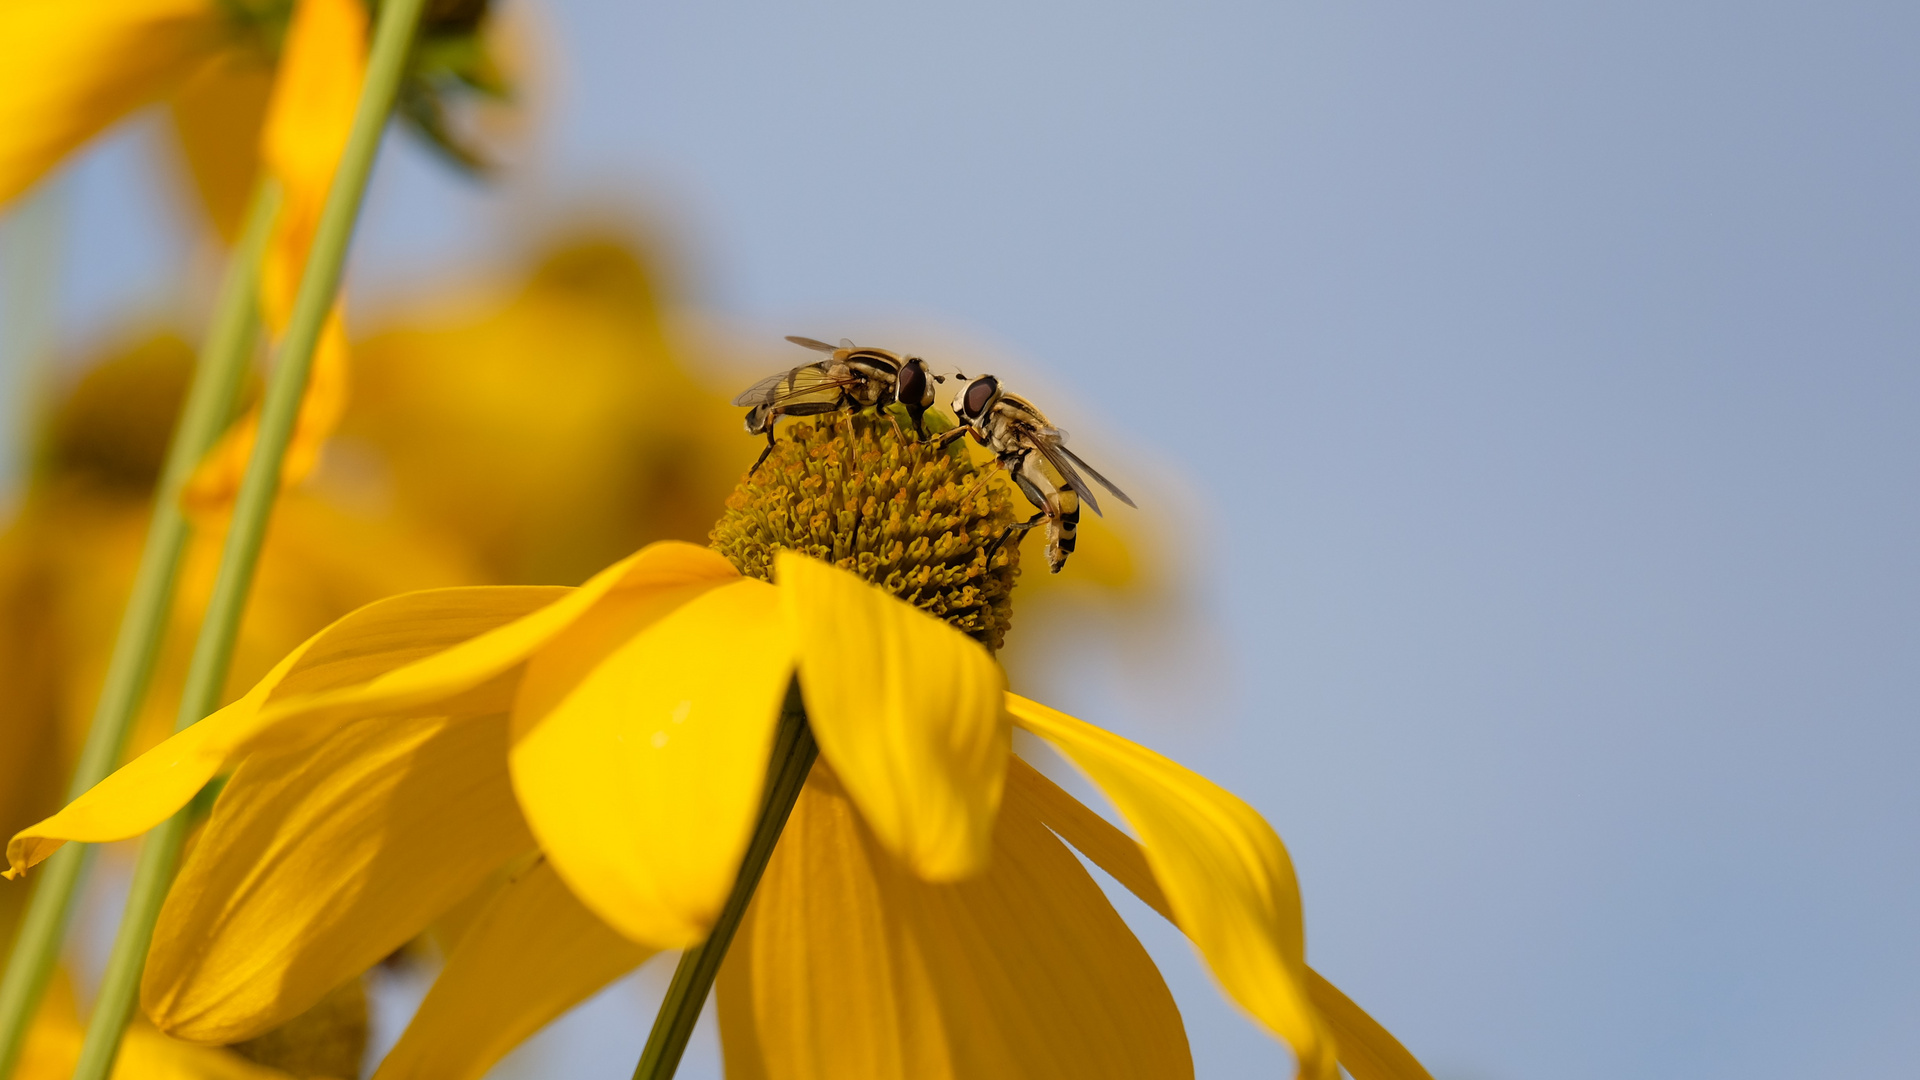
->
[8,586,560,876]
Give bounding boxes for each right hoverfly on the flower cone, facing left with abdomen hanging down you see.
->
[939,375,1133,575]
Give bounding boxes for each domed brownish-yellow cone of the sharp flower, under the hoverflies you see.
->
[710,413,1020,650]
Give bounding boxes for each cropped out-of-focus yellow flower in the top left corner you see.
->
[0,0,514,513]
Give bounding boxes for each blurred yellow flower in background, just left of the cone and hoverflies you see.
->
[336,233,755,584]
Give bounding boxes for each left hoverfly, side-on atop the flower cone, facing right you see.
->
[733,334,947,475]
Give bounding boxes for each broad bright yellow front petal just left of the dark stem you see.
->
[513,578,793,949]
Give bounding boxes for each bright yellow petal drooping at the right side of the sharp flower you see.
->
[1006,694,1338,1080]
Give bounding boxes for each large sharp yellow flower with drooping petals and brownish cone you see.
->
[8,419,1425,1080]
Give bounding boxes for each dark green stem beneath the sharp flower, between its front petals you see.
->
[634,682,820,1080]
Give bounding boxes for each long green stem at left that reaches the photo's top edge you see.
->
[73,0,424,1080]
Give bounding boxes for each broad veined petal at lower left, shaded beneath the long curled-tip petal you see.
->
[140,713,534,1043]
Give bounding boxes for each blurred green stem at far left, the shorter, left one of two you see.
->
[0,183,280,1078]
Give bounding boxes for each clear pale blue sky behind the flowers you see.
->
[8,0,1920,1080]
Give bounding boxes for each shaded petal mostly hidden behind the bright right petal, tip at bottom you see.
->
[1006,757,1432,1080]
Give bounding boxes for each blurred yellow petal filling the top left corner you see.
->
[0,0,221,204]
